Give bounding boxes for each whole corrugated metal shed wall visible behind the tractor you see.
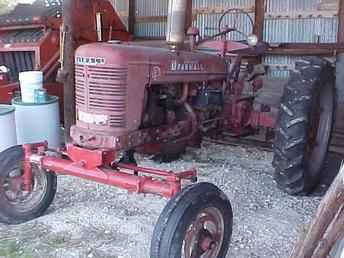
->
[112,0,338,77]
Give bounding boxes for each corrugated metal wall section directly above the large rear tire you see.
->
[264,0,338,77]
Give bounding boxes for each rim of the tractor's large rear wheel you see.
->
[305,82,334,178]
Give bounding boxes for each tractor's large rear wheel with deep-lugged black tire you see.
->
[273,58,335,195]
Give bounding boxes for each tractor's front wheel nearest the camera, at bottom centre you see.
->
[150,183,233,258]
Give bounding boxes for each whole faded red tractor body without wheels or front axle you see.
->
[71,30,268,151]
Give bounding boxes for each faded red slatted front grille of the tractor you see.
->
[75,65,128,128]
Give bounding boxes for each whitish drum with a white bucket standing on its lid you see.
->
[12,96,61,149]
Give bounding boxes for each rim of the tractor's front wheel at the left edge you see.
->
[2,162,48,213]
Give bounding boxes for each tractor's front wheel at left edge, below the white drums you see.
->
[0,146,57,224]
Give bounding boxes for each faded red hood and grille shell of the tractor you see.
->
[72,43,226,136]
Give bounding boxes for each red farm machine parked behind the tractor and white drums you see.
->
[0,0,130,116]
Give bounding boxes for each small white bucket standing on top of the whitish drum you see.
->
[19,71,43,103]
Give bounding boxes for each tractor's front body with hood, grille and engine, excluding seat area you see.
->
[71,43,228,151]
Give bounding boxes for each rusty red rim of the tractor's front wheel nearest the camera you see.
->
[182,207,224,258]
